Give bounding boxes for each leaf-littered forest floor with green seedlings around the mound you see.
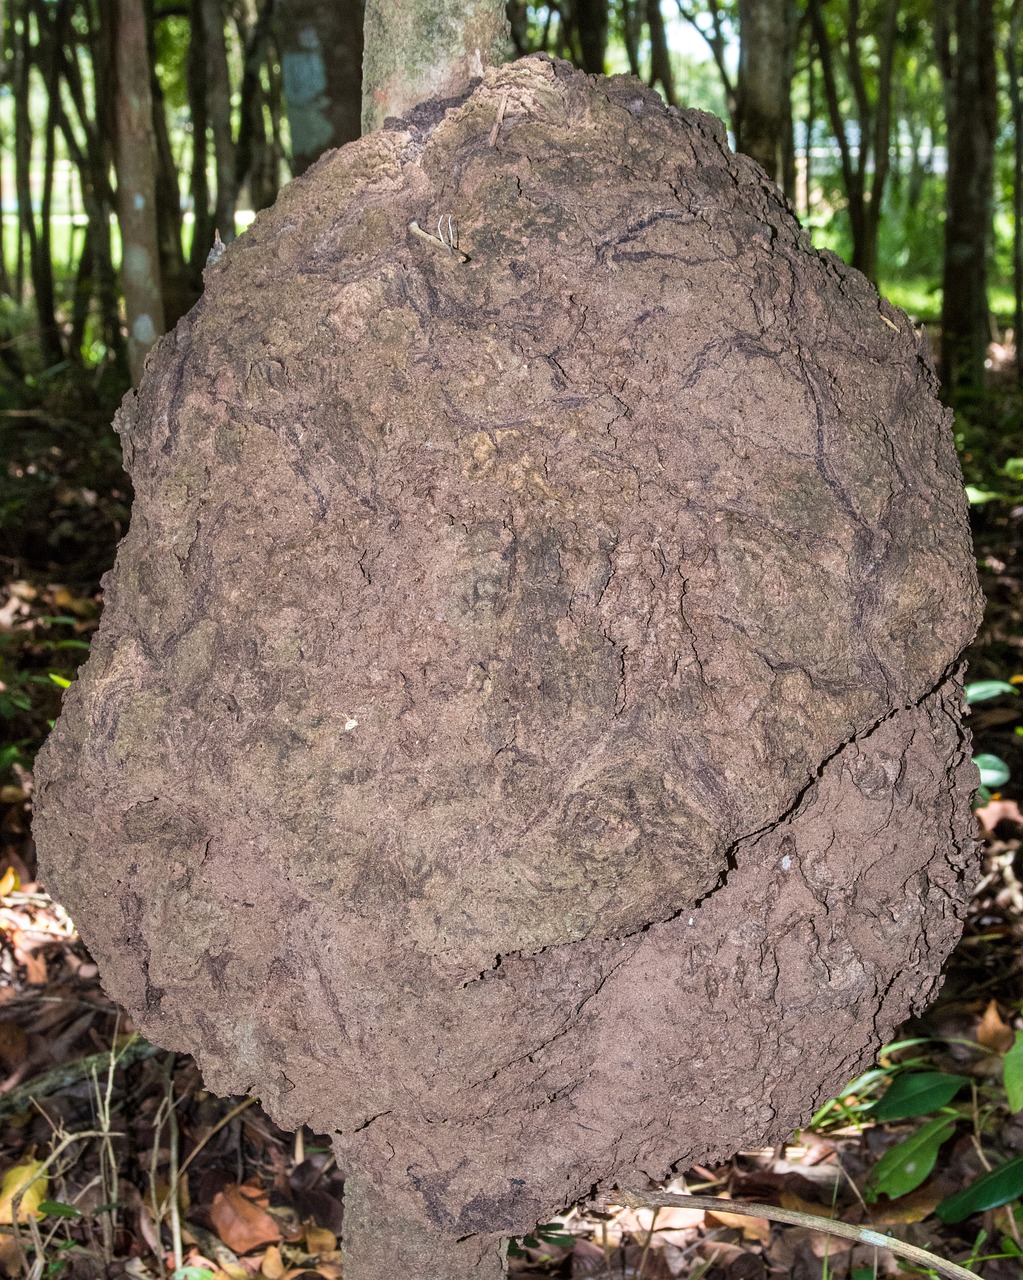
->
[0,384,1023,1280]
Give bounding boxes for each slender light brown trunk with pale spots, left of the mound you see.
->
[108,0,164,384]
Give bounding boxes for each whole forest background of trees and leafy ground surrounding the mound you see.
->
[0,0,1023,1280]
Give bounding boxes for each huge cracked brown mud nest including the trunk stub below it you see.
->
[36,59,978,1280]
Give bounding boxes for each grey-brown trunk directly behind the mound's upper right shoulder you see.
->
[735,0,793,187]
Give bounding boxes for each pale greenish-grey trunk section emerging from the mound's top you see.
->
[362,0,510,133]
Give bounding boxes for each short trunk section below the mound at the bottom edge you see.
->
[342,1175,507,1280]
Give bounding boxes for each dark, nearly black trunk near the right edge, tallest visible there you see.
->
[938,0,997,399]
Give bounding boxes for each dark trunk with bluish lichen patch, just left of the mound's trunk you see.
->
[278,0,363,174]
